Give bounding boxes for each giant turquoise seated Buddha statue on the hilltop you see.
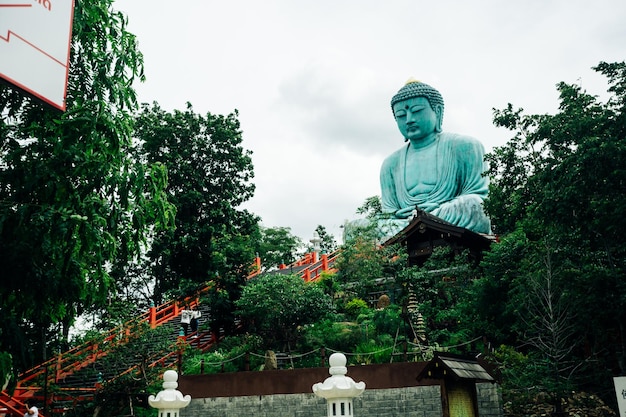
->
[380,80,491,236]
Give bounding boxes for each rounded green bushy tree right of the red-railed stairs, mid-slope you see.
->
[235,274,334,349]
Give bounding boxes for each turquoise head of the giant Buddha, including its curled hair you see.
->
[391,79,444,140]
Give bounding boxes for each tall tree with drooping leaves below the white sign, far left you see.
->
[0,0,173,370]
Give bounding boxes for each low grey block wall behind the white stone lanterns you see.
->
[180,383,502,417]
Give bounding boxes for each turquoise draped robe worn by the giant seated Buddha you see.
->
[380,133,491,233]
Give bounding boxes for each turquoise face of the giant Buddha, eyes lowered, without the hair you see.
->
[393,97,441,141]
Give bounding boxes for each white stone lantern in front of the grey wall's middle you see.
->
[313,353,365,417]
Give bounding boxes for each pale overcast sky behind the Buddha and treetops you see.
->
[114,0,626,241]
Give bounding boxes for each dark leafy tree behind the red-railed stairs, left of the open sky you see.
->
[136,103,258,303]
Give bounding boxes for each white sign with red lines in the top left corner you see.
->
[0,0,74,110]
